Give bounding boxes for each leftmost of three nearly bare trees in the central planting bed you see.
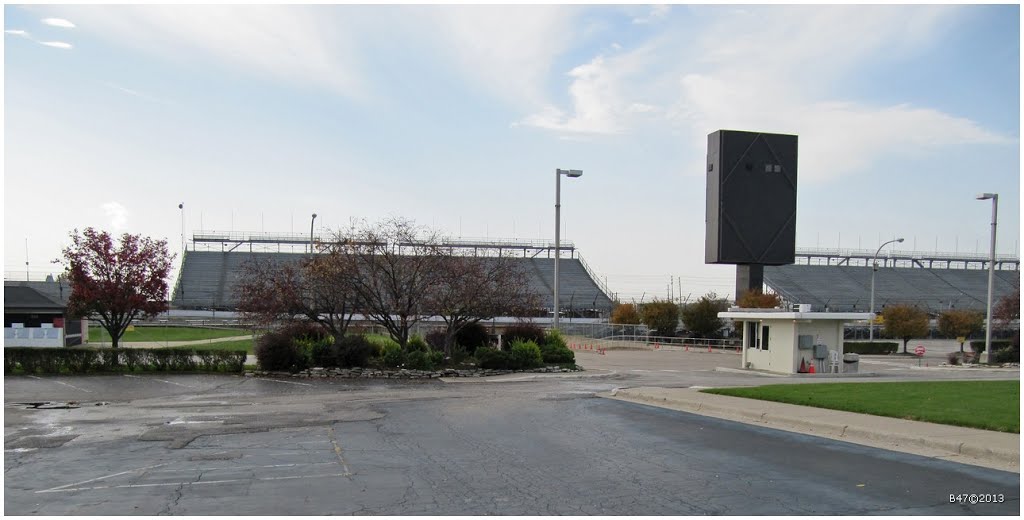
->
[236,246,356,343]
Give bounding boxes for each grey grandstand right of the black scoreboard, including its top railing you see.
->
[765,250,1020,313]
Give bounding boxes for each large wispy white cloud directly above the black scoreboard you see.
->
[669,6,1013,179]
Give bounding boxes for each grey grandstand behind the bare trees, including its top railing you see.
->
[171,232,612,317]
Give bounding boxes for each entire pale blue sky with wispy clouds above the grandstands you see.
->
[3,5,1021,301]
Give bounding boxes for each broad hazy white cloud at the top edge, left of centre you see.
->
[48,5,369,96]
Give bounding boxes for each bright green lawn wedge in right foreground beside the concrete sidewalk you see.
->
[701,381,1021,433]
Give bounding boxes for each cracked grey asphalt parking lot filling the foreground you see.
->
[4,352,1020,515]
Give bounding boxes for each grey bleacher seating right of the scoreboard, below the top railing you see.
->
[765,264,1020,312]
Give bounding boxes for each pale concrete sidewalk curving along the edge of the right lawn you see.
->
[598,387,1020,473]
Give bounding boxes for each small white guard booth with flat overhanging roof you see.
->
[718,306,870,374]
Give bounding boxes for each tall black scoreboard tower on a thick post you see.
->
[705,130,797,300]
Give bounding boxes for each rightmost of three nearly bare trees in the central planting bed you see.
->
[430,255,540,355]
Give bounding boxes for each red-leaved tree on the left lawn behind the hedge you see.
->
[57,227,174,348]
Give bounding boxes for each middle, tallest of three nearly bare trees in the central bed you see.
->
[335,218,446,348]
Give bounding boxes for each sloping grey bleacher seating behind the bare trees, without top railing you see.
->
[171,251,611,312]
